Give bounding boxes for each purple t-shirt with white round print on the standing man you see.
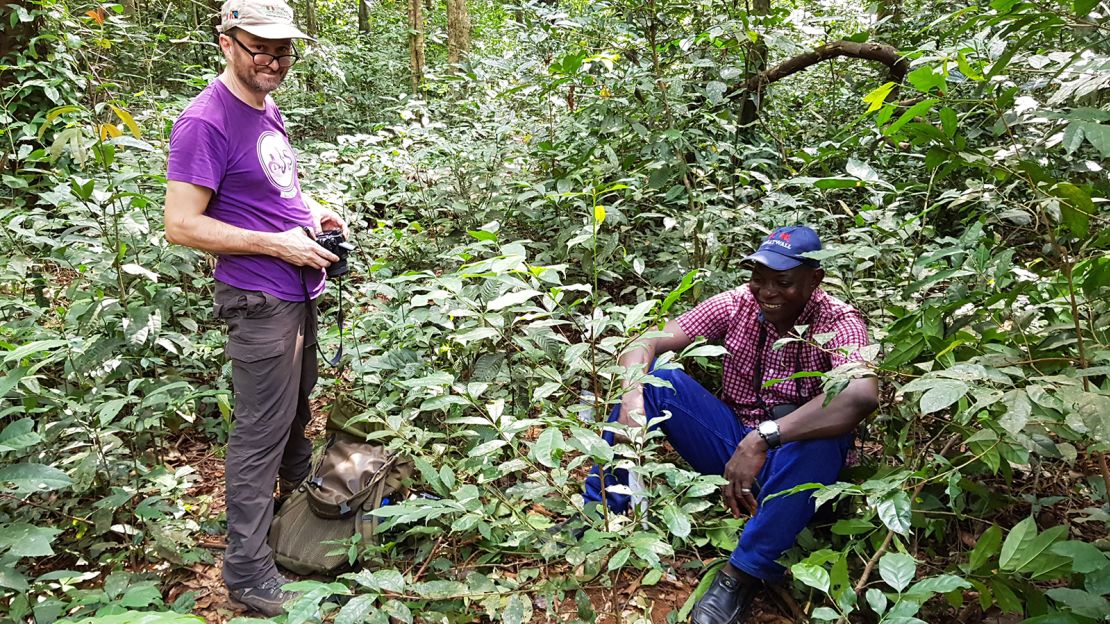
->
[167,80,324,301]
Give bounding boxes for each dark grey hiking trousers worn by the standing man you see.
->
[215,282,316,588]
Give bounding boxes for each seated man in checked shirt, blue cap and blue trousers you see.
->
[584,225,878,624]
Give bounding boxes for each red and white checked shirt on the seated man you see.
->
[677,286,868,426]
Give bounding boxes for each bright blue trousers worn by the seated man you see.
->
[583,370,855,581]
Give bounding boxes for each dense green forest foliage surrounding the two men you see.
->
[0,0,1110,623]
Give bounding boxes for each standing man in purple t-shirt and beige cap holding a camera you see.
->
[165,0,346,616]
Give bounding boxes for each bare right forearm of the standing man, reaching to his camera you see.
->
[165,180,339,269]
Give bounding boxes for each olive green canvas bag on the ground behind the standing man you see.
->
[269,432,412,574]
